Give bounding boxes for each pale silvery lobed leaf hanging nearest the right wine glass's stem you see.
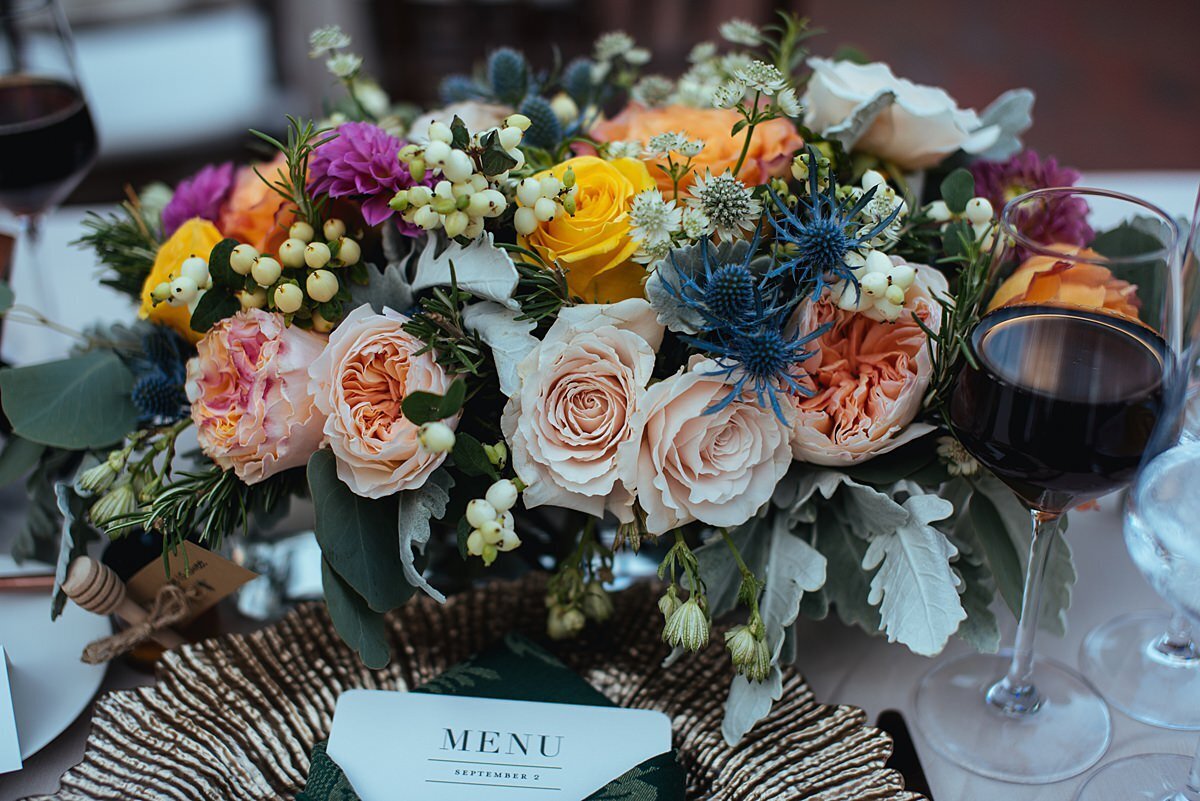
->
[863,495,967,656]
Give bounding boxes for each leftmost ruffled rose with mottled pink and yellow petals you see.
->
[185,309,325,484]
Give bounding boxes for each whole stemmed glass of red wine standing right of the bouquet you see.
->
[916,188,1182,784]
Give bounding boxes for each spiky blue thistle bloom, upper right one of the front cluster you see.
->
[769,145,900,297]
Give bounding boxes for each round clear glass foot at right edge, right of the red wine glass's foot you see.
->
[1079,612,1200,731]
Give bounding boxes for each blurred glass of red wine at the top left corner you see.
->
[0,0,97,312]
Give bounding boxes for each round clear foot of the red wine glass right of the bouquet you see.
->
[916,651,1112,784]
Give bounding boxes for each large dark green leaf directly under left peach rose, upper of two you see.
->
[308,451,413,612]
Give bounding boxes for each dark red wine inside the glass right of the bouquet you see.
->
[950,305,1168,512]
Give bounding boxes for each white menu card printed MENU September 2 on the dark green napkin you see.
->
[328,689,671,801]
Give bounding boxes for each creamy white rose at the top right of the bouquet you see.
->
[804,58,1004,170]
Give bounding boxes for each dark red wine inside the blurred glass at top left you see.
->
[0,74,97,216]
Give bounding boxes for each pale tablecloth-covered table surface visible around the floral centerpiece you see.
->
[0,171,1200,801]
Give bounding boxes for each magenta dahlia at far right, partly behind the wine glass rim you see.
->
[971,150,1096,245]
